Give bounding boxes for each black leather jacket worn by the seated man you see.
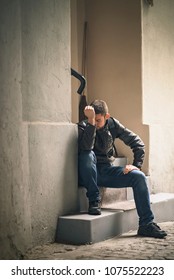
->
[78,118,145,168]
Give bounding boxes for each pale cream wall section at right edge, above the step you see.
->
[142,0,174,192]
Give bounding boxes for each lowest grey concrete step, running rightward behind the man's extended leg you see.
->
[56,193,174,245]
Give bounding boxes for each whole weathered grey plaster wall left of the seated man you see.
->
[0,0,77,259]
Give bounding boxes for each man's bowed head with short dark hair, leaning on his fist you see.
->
[90,100,110,129]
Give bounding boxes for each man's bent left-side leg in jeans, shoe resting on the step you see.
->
[78,151,101,215]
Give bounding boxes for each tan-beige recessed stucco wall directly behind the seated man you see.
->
[72,0,149,174]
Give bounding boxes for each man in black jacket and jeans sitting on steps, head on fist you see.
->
[78,100,167,238]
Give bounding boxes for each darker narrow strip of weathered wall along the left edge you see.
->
[0,1,31,258]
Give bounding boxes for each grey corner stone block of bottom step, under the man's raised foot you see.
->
[56,210,123,244]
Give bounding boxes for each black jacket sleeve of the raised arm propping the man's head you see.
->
[78,121,96,151]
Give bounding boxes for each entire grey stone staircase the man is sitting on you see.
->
[56,158,174,245]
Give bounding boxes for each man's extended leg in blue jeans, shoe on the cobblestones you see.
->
[98,166,167,238]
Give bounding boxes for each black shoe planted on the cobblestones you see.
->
[137,223,167,238]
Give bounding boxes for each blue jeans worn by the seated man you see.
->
[78,151,154,225]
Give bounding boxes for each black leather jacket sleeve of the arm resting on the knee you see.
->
[114,119,145,168]
